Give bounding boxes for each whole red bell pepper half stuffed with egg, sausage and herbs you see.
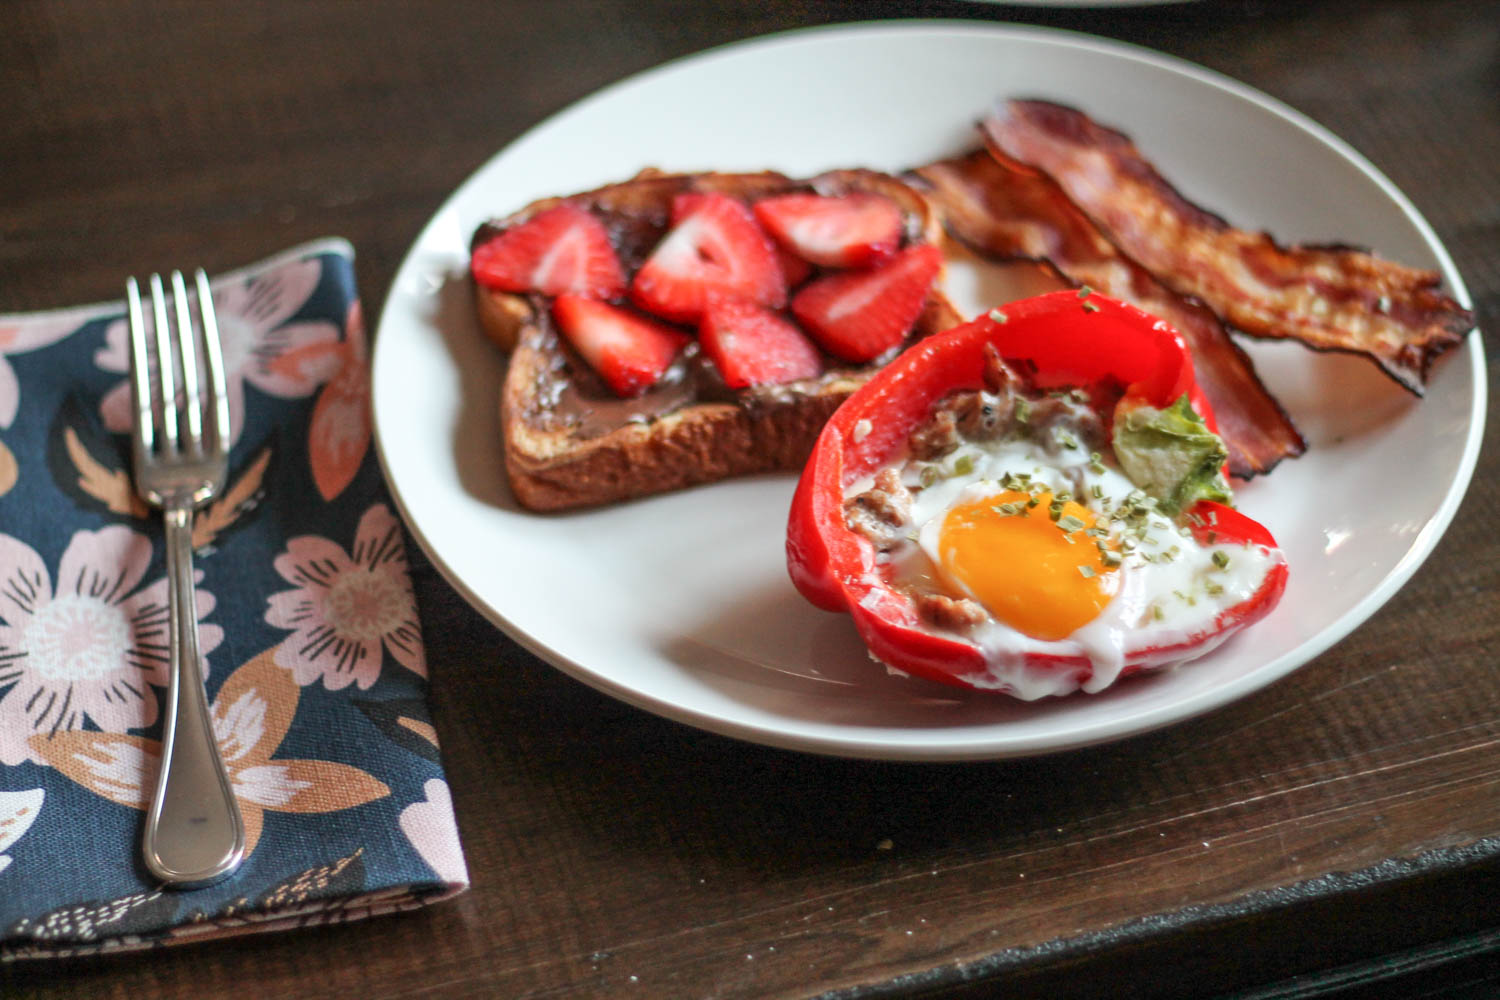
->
[786,289,1287,700]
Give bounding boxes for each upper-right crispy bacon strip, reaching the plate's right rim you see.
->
[983,100,1475,396]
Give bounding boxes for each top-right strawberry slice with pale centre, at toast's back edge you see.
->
[755,190,905,267]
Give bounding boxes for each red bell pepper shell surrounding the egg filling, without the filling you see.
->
[786,291,1287,687]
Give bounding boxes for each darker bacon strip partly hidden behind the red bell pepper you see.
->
[914,150,1307,478]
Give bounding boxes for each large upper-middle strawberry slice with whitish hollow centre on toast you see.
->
[630,192,786,322]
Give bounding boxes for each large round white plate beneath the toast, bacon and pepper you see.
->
[374,21,1485,760]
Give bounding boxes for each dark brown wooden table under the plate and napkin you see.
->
[0,0,1500,1000]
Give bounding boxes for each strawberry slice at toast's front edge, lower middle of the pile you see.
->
[698,295,824,388]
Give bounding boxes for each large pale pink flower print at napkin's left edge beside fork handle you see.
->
[0,525,224,765]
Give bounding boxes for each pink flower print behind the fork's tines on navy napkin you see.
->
[95,258,344,444]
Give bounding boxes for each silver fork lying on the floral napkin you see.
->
[125,268,245,888]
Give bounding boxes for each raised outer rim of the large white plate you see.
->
[371,18,1488,762]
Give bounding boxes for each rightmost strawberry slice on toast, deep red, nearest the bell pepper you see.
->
[792,243,942,364]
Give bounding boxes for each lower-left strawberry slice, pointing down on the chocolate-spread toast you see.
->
[552,295,692,396]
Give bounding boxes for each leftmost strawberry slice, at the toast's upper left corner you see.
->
[470,201,626,298]
